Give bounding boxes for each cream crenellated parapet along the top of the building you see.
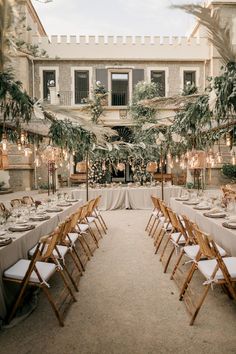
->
[31,35,210,60]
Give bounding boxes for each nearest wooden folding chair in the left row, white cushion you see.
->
[3,230,76,326]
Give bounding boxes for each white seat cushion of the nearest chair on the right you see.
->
[198,257,236,280]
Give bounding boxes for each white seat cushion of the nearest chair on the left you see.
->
[4,259,56,283]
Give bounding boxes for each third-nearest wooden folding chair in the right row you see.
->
[160,208,188,273]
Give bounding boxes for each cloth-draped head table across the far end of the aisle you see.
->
[72,186,182,210]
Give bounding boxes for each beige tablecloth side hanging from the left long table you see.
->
[0,201,81,319]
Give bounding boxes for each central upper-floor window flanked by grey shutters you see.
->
[111,73,129,106]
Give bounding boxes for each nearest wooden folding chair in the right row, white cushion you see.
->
[180,228,236,325]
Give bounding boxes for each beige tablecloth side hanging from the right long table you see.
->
[170,198,236,256]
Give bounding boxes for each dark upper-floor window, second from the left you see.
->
[75,70,89,104]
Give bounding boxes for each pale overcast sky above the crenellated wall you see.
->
[32,0,202,36]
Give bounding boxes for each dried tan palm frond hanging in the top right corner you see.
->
[171,4,236,64]
